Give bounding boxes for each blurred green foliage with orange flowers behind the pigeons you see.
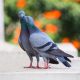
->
[3,0,80,55]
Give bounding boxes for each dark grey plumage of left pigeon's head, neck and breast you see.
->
[18,11,39,67]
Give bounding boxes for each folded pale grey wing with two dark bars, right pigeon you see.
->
[29,32,73,57]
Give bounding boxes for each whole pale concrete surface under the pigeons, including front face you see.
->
[0,43,80,80]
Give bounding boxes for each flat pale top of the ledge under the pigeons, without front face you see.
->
[0,50,80,72]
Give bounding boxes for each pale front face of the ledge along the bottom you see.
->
[0,72,80,80]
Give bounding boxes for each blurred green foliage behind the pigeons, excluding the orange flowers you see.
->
[4,0,80,41]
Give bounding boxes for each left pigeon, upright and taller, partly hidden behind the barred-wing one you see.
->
[18,10,58,68]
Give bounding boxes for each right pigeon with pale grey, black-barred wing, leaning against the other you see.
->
[24,13,73,69]
